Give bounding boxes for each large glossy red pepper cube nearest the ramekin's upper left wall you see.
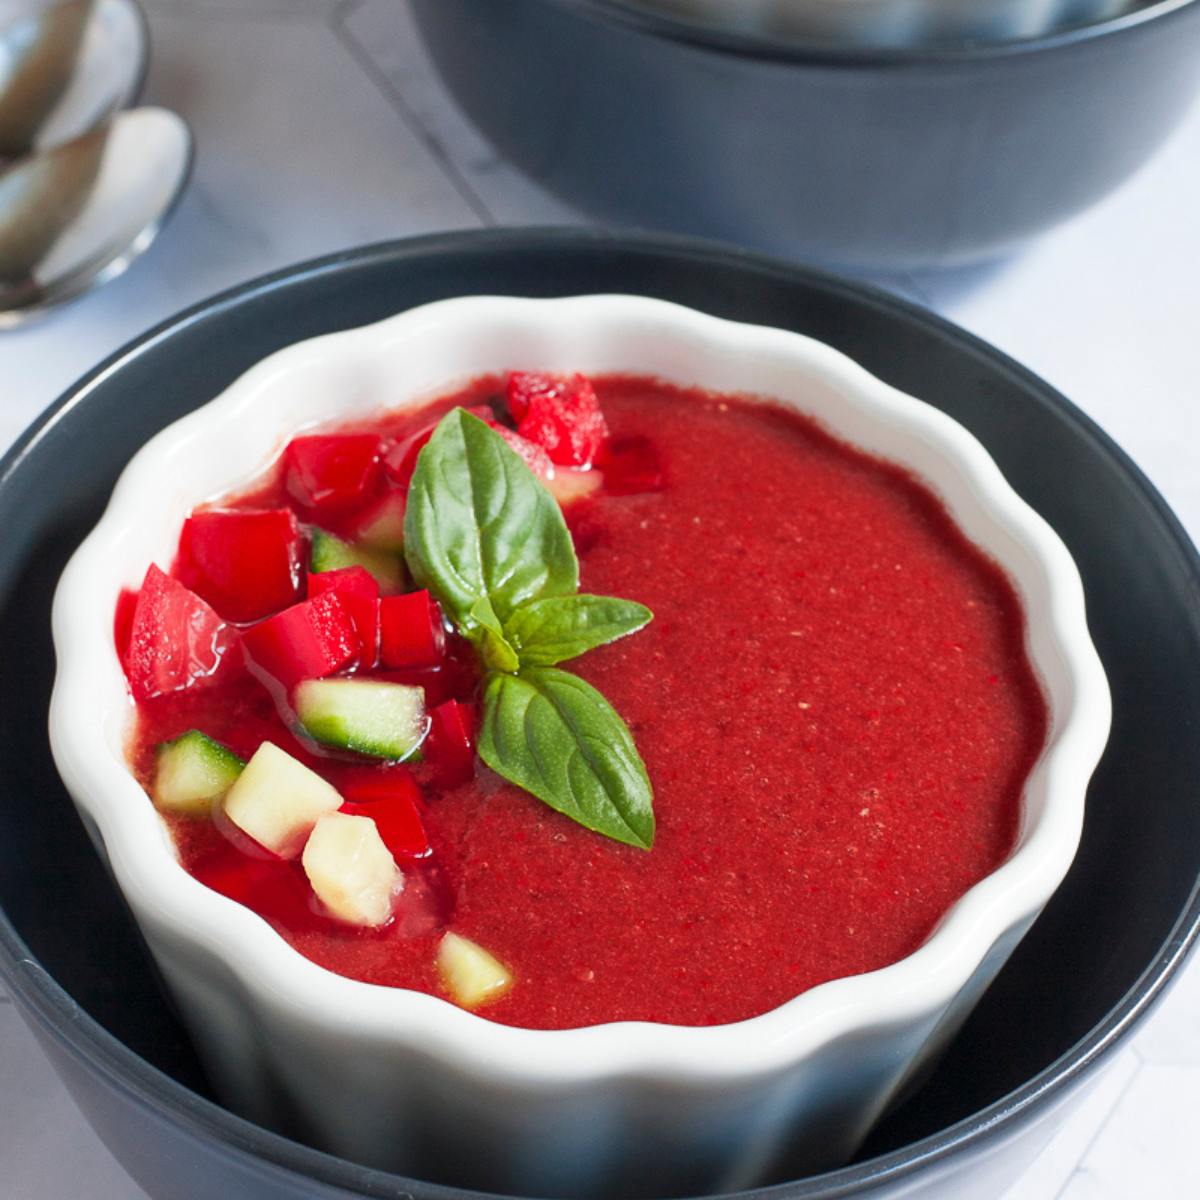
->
[176,509,304,622]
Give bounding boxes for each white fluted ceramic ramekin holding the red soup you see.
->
[50,295,1110,1196]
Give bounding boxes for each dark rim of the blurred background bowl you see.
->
[564,0,1200,68]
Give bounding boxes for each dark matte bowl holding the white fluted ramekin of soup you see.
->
[0,230,1200,1200]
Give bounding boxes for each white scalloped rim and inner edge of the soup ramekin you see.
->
[50,295,1111,1085]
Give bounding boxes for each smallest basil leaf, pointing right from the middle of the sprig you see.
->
[504,594,654,666]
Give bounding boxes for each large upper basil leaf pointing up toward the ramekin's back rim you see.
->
[404,408,580,637]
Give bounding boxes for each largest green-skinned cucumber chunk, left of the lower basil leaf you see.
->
[294,679,430,762]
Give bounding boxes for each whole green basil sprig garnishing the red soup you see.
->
[404,408,654,850]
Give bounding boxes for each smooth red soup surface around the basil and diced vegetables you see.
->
[118,377,1046,1028]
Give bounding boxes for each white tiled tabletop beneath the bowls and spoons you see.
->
[0,0,1200,1200]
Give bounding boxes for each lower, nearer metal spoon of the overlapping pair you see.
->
[0,108,192,329]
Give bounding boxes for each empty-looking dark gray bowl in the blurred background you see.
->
[413,0,1200,268]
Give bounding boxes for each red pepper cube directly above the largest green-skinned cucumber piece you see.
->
[241,592,362,688]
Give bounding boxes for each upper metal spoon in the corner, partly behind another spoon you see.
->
[0,0,150,161]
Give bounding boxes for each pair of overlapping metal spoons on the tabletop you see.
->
[0,0,192,328]
